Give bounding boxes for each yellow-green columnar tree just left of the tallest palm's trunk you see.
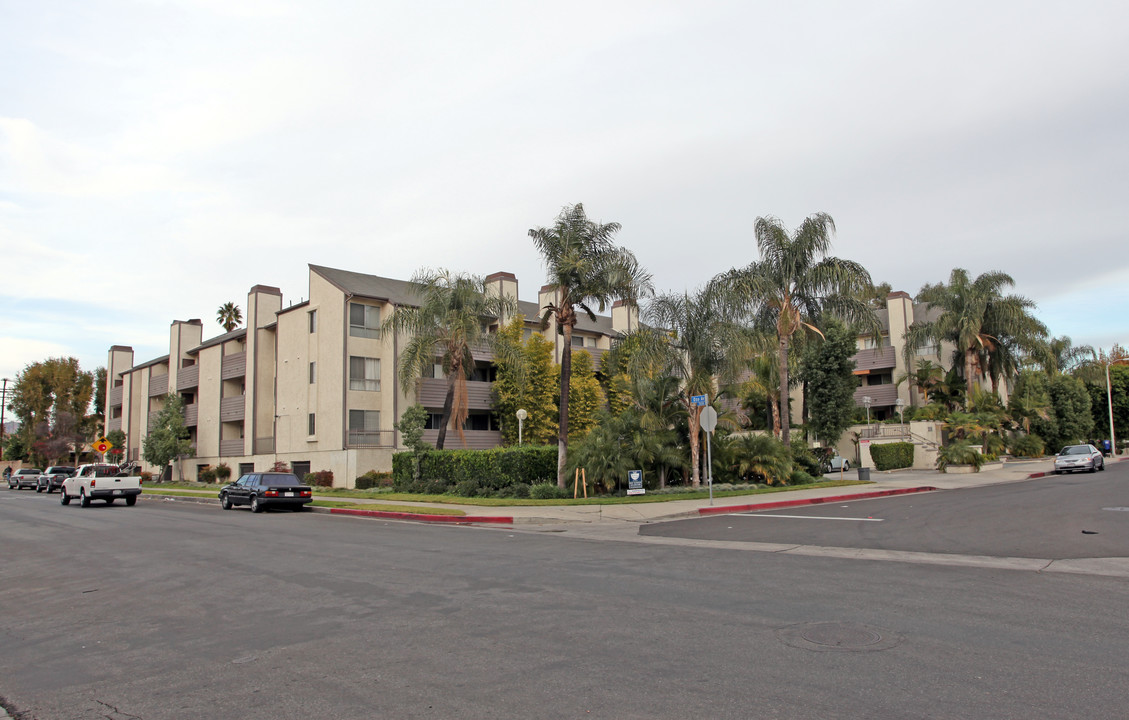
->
[493,315,559,445]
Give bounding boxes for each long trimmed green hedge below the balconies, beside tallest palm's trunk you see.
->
[392,445,557,497]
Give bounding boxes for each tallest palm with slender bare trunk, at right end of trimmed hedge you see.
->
[530,203,651,488]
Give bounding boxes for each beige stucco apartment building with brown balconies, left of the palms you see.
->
[105,265,638,486]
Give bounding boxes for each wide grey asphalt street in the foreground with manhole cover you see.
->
[0,483,1129,720]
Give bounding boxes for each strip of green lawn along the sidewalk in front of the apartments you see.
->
[146,480,873,513]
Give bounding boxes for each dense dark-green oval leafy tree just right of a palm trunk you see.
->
[800,319,858,447]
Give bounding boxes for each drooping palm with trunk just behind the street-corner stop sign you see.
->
[624,284,755,488]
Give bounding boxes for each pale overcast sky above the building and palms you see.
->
[0,0,1129,388]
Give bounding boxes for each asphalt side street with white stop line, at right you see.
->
[640,463,1129,560]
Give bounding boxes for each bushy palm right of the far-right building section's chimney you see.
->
[907,267,1047,406]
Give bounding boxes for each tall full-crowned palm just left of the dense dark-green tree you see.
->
[723,212,875,445]
